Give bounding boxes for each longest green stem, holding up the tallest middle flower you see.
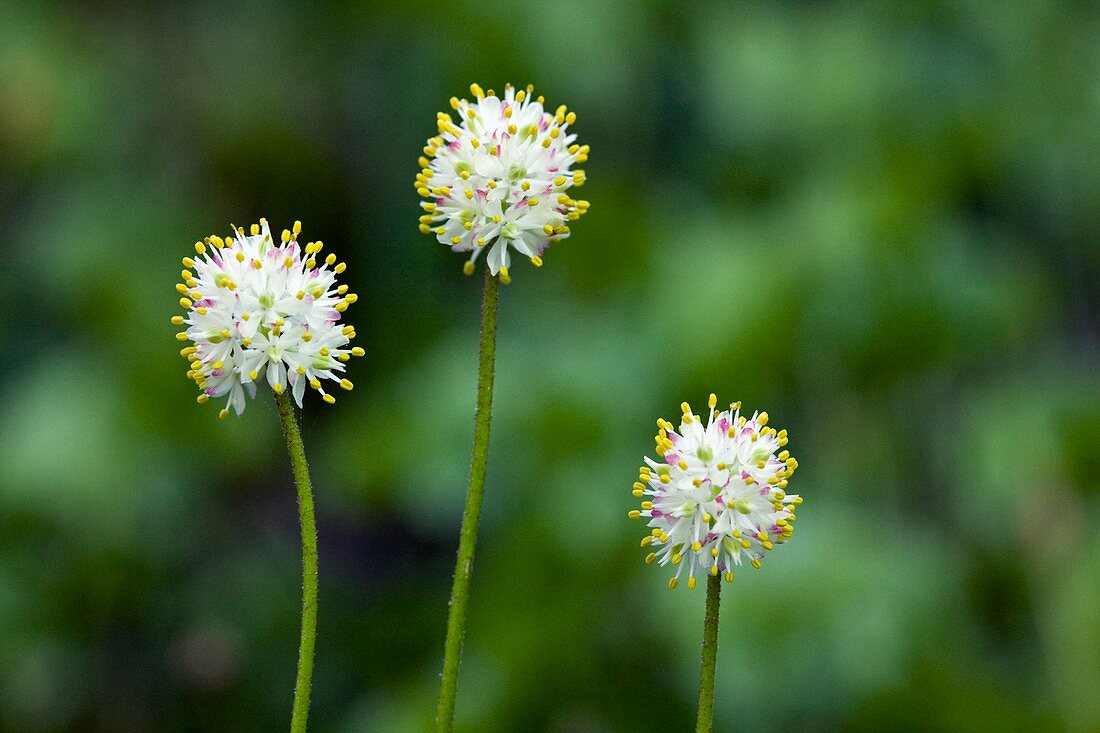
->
[436,267,501,733]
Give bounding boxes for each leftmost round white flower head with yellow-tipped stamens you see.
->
[172,219,364,417]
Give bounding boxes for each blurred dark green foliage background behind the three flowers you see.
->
[0,0,1100,733]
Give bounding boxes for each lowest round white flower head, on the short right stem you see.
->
[630,394,802,588]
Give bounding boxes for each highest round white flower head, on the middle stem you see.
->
[416,84,589,283]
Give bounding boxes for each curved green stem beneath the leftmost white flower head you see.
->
[275,392,317,733]
